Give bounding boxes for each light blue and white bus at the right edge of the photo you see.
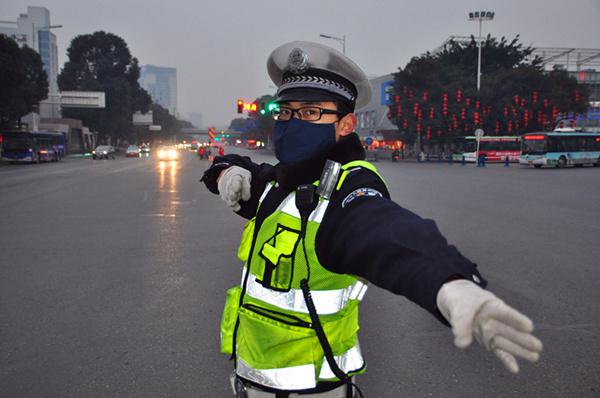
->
[519,131,600,169]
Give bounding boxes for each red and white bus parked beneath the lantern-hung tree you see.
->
[463,135,521,163]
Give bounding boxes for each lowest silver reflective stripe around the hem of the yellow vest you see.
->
[236,344,364,390]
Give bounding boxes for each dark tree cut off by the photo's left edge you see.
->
[0,34,48,128]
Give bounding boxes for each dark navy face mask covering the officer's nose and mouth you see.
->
[274,118,336,164]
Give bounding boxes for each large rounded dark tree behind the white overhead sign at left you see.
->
[58,31,152,142]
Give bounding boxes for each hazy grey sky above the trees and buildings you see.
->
[0,0,600,126]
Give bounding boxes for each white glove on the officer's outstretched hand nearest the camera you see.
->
[437,279,542,373]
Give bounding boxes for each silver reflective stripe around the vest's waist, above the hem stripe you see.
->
[242,268,368,315]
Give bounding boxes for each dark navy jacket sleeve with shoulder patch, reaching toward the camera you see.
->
[315,169,487,324]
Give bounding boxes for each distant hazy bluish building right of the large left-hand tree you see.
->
[139,65,178,117]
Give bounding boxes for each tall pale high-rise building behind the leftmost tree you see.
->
[0,6,61,117]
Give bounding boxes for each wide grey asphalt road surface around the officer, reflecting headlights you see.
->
[0,152,600,398]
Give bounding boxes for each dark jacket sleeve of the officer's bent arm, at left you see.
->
[200,154,275,219]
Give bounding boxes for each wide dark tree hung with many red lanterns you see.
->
[389,36,588,143]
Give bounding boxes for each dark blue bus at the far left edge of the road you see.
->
[0,131,66,163]
